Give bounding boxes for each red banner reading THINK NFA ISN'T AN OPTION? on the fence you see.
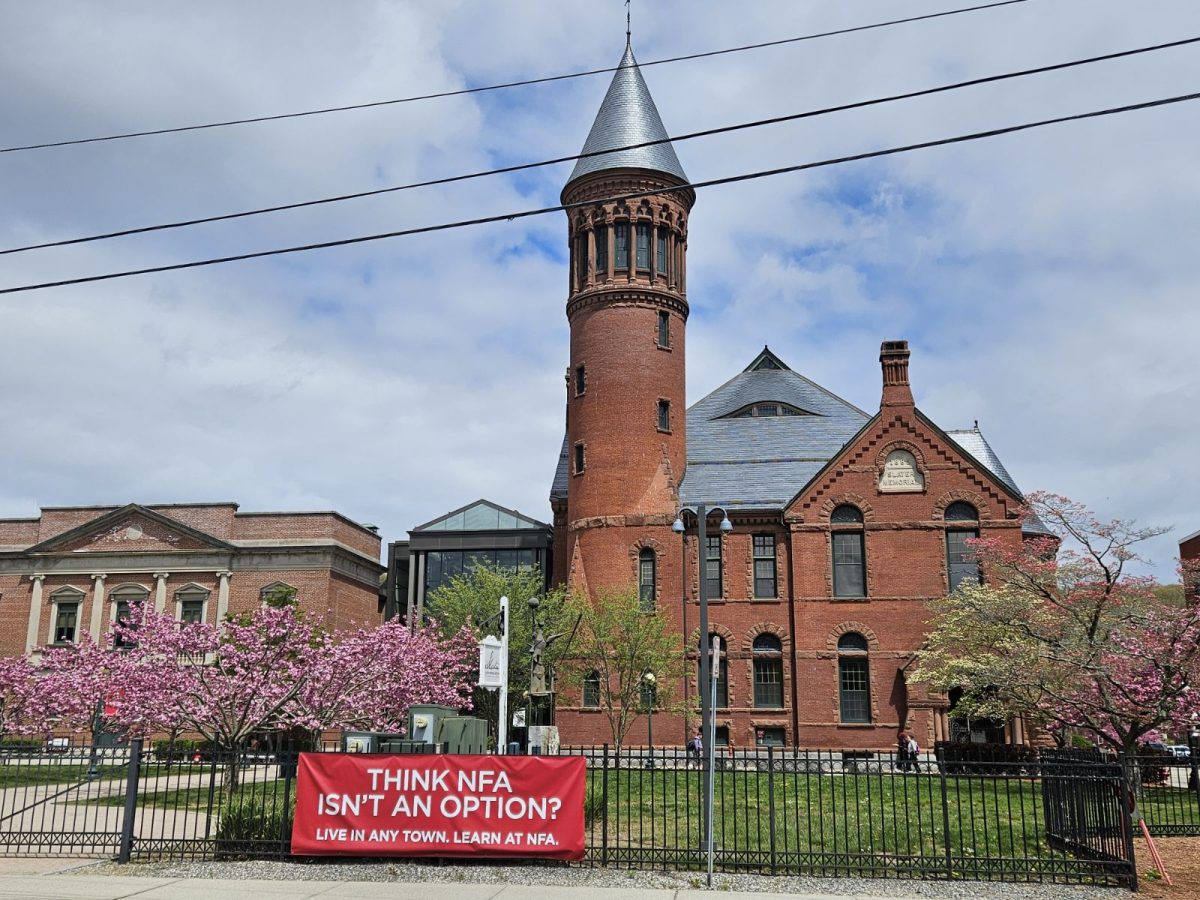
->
[292,754,586,859]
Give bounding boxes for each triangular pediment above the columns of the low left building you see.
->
[26,503,234,553]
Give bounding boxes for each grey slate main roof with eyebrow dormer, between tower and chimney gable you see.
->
[679,348,871,509]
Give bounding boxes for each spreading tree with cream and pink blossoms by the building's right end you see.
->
[912,493,1200,752]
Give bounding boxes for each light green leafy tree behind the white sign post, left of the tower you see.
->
[426,565,575,734]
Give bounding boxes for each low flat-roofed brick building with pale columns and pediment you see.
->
[0,503,383,655]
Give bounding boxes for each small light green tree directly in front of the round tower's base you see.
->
[562,587,685,750]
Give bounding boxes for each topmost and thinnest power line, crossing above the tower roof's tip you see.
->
[0,0,1028,154]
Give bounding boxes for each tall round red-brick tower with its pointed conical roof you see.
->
[556,47,696,602]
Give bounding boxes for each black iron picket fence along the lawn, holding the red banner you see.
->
[0,743,1200,886]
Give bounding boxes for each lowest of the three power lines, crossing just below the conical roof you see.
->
[0,92,1200,294]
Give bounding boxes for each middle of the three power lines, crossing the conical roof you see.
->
[0,36,1200,256]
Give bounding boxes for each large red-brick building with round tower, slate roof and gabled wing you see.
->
[551,48,1037,749]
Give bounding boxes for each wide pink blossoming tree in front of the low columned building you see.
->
[42,604,476,787]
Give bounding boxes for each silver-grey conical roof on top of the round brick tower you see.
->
[568,47,688,184]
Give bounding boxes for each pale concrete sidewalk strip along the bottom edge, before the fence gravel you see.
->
[0,874,917,900]
